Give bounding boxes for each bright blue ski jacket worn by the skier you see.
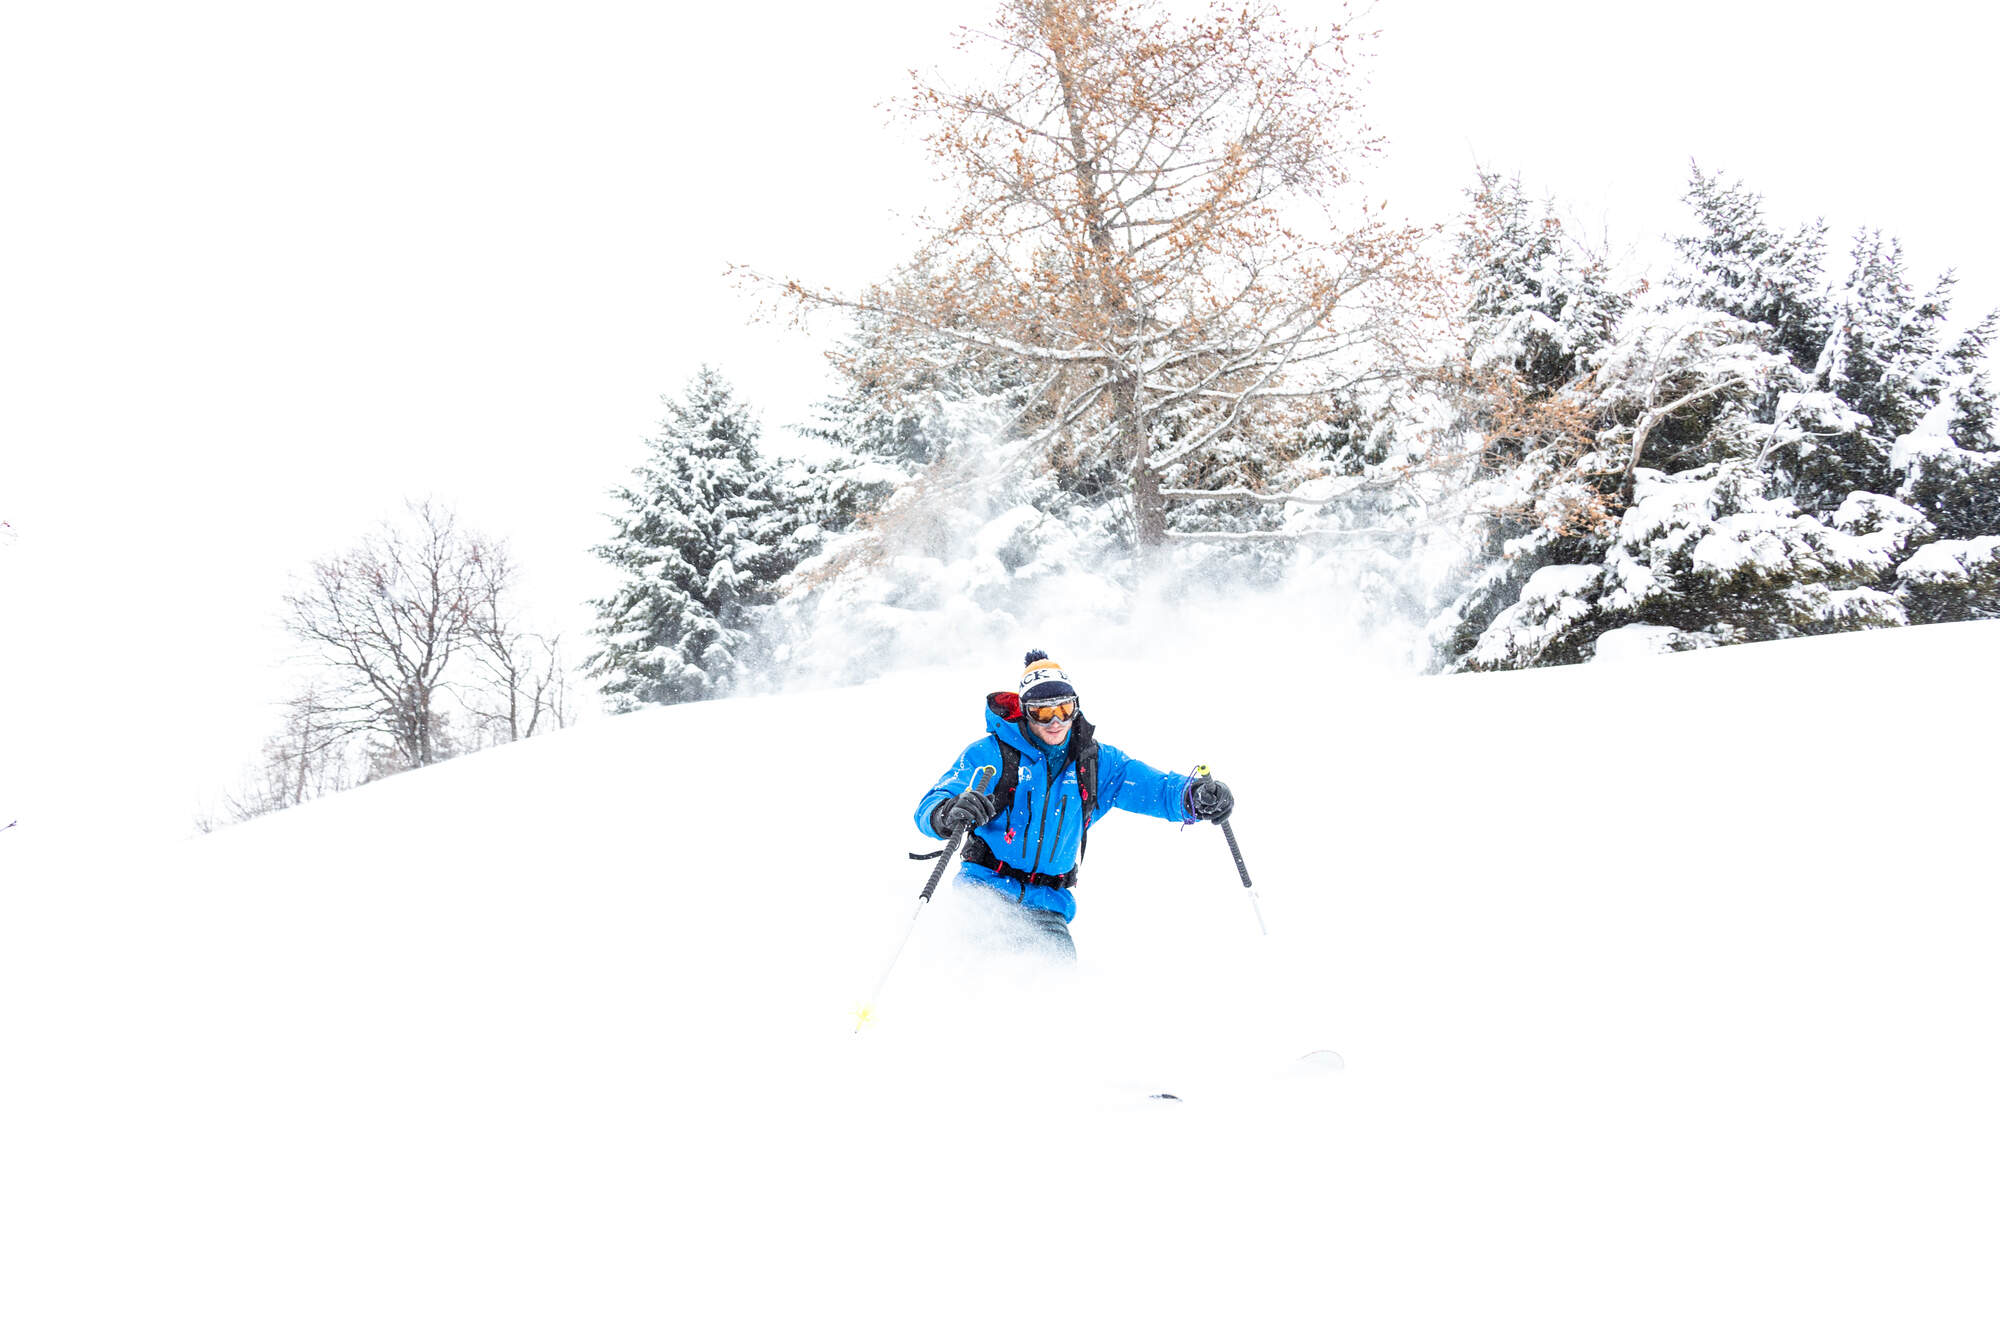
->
[916,693,1192,921]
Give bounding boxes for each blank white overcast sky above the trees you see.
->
[0,0,2000,833]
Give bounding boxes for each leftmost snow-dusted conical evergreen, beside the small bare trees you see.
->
[586,366,816,713]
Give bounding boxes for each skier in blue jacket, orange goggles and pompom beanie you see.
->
[916,650,1236,959]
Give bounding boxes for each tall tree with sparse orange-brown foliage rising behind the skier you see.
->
[756,0,1446,546]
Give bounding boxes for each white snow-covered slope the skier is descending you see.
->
[0,624,2000,1333]
